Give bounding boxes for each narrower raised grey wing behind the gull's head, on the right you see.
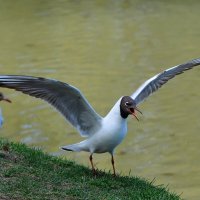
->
[131,58,200,105]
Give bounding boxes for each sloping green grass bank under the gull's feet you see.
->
[0,139,180,200]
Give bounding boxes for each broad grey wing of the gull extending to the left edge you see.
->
[0,75,102,137]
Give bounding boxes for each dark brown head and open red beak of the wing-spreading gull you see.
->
[120,96,141,120]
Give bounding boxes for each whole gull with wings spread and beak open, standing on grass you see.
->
[0,58,200,176]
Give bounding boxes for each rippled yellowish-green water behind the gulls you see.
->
[0,0,200,199]
